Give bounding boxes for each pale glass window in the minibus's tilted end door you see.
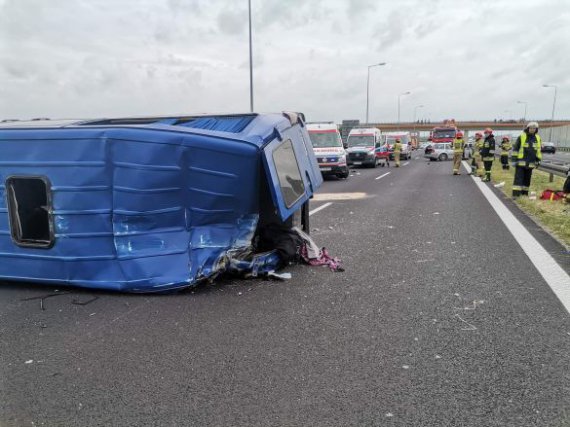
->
[273,139,305,208]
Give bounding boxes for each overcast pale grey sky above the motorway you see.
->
[0,0,570,123]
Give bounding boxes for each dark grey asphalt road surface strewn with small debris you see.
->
[0,155,570,427]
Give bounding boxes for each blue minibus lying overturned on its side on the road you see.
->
[0,113,322,292]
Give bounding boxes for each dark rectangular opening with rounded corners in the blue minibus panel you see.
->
[6,177,55,248]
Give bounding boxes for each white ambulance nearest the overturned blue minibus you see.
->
[307,122,350,178]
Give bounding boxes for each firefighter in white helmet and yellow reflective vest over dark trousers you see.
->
[512,122,542,198]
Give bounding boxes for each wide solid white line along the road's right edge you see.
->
[463,161,570,313]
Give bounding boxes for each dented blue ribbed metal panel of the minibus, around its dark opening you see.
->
[0,124,261,292]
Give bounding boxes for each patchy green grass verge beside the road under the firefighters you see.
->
[491,159,570,247]
